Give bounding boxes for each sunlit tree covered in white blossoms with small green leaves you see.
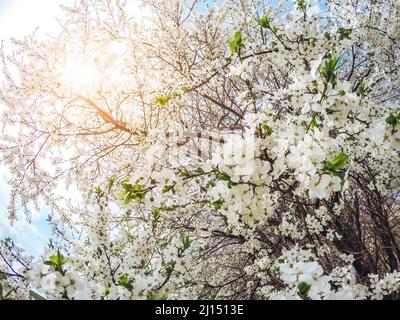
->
[0,0,400,300]
